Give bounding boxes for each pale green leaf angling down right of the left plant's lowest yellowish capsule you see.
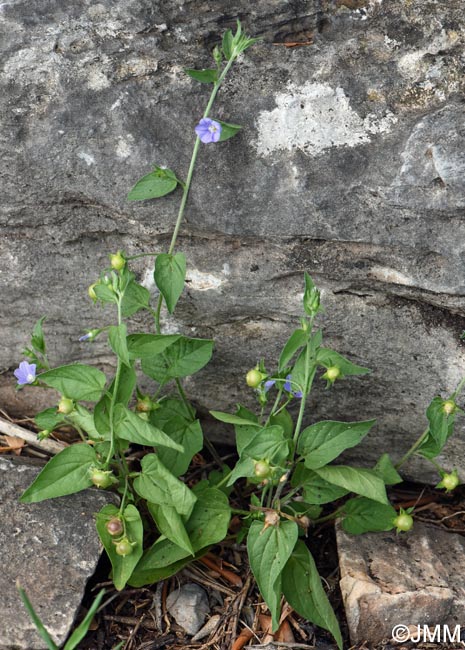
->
[134,454,196,516]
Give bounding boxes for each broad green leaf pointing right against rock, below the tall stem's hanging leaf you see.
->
[141,336,213,385]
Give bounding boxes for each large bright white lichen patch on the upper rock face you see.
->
[254,82,397,156]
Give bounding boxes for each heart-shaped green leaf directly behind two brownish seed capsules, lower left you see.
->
[96,504,144,591]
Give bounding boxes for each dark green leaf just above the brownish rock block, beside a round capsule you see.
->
[342,497,397,535]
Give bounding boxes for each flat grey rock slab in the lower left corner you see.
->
[0,458,114,650]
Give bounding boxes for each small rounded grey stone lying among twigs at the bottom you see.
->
[166,582,210,635]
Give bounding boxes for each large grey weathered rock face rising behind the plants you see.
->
[0,0,465,480]
